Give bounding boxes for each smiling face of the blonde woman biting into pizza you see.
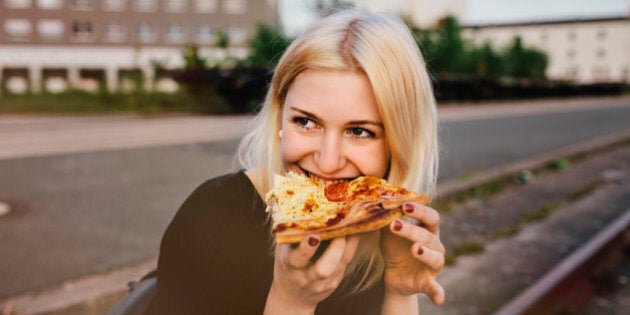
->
[281,70,389,182]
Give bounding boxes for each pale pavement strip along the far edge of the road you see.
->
[0,97,630,160]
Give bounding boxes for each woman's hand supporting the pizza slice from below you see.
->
[265,235,360,314]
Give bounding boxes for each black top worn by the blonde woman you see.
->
[149,171,384,314]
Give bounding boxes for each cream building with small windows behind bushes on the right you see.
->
[463,16,630,84]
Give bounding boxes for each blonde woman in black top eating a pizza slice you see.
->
[151,11,444,314]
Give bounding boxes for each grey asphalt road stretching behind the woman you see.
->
[0,98,630,300]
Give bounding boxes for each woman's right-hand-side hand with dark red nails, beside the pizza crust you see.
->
[381,202,445,305]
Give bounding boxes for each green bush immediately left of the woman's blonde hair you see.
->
[247,23,291,68]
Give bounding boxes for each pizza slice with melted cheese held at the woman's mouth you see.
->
[265,172,429,244]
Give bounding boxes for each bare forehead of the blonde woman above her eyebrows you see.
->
[284,69,381,122]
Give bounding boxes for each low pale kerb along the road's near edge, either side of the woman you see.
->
[0,129,630,315]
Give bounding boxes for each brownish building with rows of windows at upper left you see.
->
[0,0,278,93]
